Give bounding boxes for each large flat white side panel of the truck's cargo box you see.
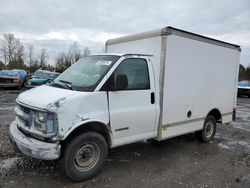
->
[162,35,239,132]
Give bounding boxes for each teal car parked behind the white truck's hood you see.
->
[26,70,60,87]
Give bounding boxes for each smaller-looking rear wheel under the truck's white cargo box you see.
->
[195,115,216,143]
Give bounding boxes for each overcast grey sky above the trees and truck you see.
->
[0,0,250,65]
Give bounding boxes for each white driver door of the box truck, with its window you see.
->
[108,58,156,146]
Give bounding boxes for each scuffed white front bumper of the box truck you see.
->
[10,121,61,160]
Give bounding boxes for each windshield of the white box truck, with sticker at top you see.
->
[54,55,119,91]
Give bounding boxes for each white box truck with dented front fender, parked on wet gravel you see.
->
[10,27,241,181]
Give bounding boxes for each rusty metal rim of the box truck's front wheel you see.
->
[74,143,100,171]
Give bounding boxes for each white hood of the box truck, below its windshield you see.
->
[16,85,78,109]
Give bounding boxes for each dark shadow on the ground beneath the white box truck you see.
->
[3,134,219,187]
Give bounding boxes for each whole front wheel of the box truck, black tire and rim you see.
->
[62,132,108,182]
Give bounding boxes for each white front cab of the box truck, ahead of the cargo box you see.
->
[10,54,158,180]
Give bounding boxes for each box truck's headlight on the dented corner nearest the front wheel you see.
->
[34,112,58,136]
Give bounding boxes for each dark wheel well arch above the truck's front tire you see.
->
[61,122,111,149]
